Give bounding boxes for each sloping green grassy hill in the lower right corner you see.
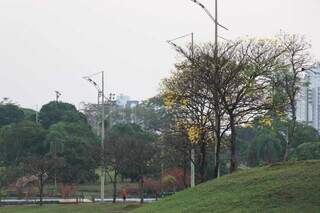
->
[133,161,320,213]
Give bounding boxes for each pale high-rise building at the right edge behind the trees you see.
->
[297,67,320,132]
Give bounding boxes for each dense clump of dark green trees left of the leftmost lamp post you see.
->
[0,101,97,205]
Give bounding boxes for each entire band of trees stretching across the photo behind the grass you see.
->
[0,33,320,205]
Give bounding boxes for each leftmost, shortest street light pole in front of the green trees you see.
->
[84,71,105,202]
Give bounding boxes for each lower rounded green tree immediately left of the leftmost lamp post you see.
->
[46,122,98,183]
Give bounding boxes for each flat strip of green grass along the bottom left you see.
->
[0,204,139,213]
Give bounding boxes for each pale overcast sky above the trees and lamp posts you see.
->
[0,0,320,108]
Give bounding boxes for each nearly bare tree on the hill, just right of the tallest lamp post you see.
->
[218,40,283,173]
